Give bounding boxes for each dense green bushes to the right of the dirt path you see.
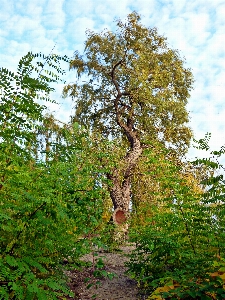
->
[125,135,225,299]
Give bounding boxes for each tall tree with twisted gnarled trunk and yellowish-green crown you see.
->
[64,12,193,223]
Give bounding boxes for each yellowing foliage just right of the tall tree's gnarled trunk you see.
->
[132,138,206,225]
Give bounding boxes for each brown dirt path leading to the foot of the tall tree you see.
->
[64,246,147,300]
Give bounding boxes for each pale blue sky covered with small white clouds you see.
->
[0,0,225,165]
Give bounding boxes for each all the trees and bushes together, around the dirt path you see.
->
[0,12,225,300]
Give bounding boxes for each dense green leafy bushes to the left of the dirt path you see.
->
[0,53,110,300]
